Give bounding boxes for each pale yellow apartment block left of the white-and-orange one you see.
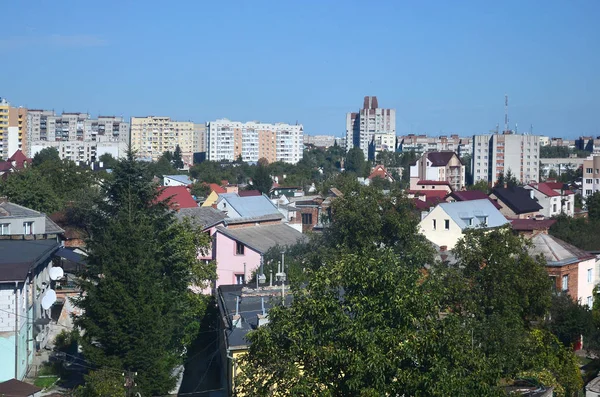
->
[131,116,201,164]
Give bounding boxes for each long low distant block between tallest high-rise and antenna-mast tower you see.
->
[398,134,473,157]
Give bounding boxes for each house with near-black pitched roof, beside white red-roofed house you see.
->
[490,186,542,219]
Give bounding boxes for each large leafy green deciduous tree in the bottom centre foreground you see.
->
[236,248,503,396]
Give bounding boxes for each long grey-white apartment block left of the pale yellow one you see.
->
[26,109,129,162]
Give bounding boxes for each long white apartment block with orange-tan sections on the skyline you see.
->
[206,119,304,164]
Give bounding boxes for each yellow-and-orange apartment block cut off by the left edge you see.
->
[0,98,27,159]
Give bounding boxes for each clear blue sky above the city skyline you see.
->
[0,0,600,137]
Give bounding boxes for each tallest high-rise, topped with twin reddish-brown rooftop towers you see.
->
[346,96,396,159]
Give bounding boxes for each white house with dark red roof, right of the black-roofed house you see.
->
[524,182,575,218]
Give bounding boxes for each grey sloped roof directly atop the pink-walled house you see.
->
[217,223,306,254]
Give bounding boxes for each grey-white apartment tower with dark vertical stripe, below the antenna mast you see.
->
[471,133,540,184]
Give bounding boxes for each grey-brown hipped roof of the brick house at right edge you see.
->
[530,233,594,266]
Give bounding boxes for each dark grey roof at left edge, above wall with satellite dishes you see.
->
[0,239,60,282]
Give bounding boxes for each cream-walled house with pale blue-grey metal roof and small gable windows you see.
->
[419,199,508,250]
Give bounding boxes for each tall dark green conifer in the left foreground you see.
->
[75,152,215,395]
